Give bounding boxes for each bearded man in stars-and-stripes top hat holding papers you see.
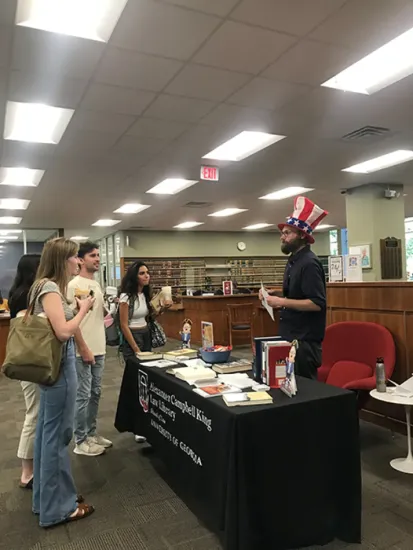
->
[260,197,327,379]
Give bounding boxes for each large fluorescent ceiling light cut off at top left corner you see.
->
[16,0,127,42]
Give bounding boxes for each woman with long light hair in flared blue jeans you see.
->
[29,238,94,527]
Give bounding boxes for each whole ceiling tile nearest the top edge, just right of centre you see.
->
[195,21,296,74]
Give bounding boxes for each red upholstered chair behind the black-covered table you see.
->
[317,321,396,391]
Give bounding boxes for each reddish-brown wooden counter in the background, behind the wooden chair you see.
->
[159,294,278,345]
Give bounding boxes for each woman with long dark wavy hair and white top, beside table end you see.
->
[119,261,154,361]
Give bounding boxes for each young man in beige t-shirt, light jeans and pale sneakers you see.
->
[67,242,112,456]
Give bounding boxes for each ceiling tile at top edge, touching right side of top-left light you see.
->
[111,0,221,60]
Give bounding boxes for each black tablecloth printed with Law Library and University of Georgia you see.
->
[115,360,361,550]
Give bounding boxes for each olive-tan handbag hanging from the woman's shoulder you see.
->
[2,283,64,386]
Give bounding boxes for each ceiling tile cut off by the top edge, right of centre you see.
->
[231,0,346,36]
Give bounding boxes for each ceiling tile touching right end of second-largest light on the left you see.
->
[69,109,135,135]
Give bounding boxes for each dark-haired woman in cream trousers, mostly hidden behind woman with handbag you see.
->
[9,254,40,489]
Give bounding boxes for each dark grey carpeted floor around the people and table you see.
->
[0,343,413,550]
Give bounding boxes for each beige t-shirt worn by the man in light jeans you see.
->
[67,275,106,356]
